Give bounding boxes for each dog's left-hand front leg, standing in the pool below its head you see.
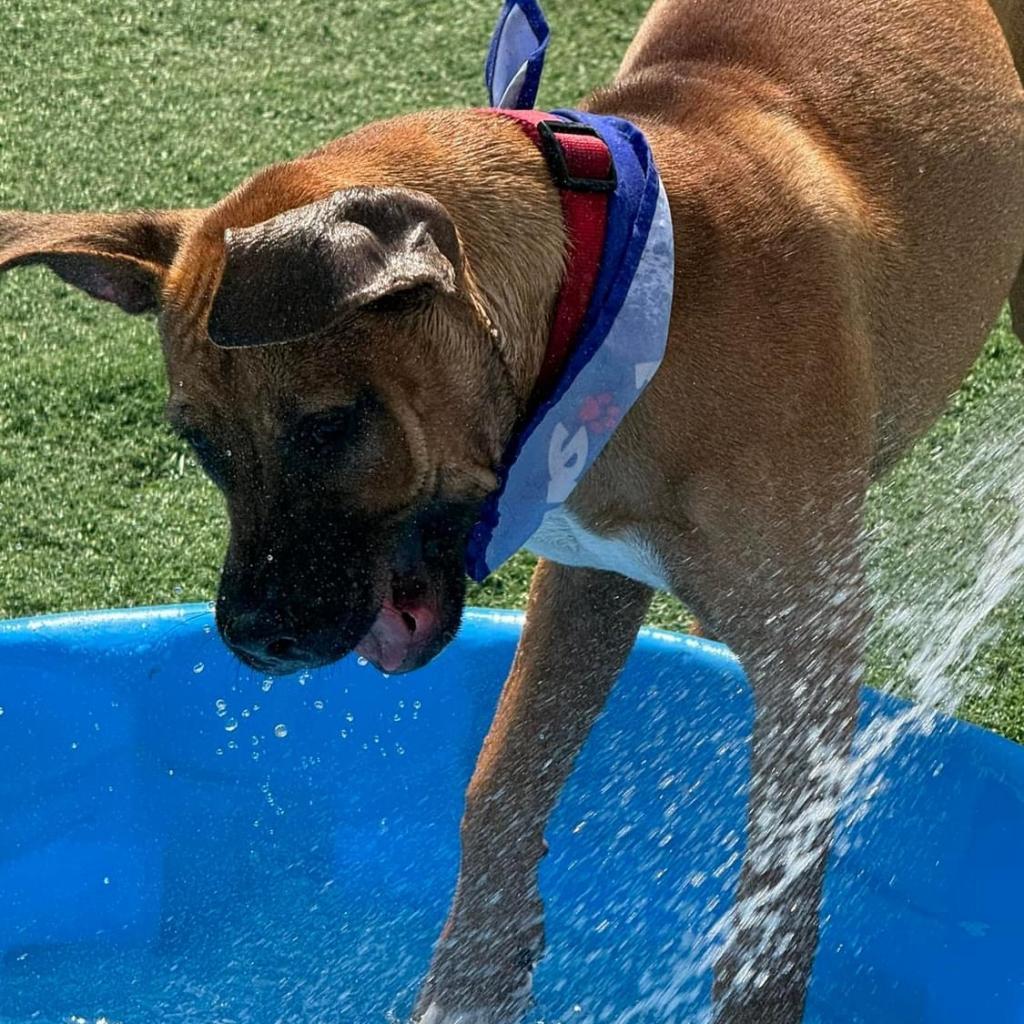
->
[414,561,650,1024]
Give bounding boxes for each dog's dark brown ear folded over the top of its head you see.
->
[208,187,461,348]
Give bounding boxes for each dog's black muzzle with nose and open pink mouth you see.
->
[217,499,472,675]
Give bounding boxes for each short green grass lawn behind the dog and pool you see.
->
[0,0,1024,741]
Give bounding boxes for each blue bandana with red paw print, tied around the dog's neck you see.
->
[466,0,675,580]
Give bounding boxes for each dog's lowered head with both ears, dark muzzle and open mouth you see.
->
[0,149,548,674]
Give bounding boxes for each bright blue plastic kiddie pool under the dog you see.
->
[0,606,1024,1024]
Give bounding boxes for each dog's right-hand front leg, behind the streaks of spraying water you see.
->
[673,473,867,1024]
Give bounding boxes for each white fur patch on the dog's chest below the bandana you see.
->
[526,506,669,590]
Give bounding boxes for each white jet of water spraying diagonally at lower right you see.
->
[598,337,1024,1024]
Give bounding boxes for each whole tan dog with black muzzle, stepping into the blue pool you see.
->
[0,0,1024,1024]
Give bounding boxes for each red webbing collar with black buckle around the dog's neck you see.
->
[490,108,615,417]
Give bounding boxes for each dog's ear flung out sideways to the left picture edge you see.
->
[0,210,199,313]
